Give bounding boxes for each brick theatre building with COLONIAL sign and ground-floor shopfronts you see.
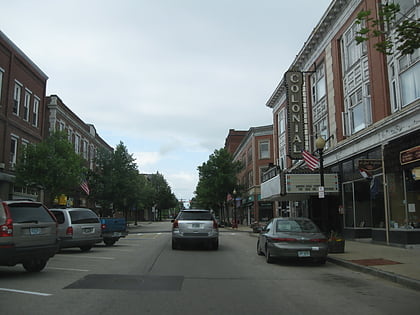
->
[262,0,420,244]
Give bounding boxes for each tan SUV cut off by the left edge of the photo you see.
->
[0,200,58,272]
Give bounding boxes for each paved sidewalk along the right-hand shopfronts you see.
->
[225,226,420,291]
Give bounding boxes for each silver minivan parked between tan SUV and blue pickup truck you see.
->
[51,208,102,251]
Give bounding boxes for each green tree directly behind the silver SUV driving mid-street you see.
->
[194,148,242,215]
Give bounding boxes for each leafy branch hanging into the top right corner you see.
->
[356,3,420,55]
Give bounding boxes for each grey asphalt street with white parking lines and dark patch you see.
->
[0,222,420,315]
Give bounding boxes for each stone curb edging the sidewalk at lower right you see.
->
[327,256,420,291]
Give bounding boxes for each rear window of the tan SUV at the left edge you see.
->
[8,203,54,223]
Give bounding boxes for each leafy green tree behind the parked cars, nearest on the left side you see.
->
[16,131,86,205]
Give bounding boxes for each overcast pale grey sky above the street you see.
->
[0,0,331,199]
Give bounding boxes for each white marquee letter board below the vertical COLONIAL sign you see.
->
[286,174,338,195]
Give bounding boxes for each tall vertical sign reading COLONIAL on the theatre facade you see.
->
[285,71,305,160]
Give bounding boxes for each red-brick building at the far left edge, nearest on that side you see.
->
[0,31,48,199]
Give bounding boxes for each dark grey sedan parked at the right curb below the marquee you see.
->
[257,217,328,264]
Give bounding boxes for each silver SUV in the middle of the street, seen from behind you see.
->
[172,209,219,250]
